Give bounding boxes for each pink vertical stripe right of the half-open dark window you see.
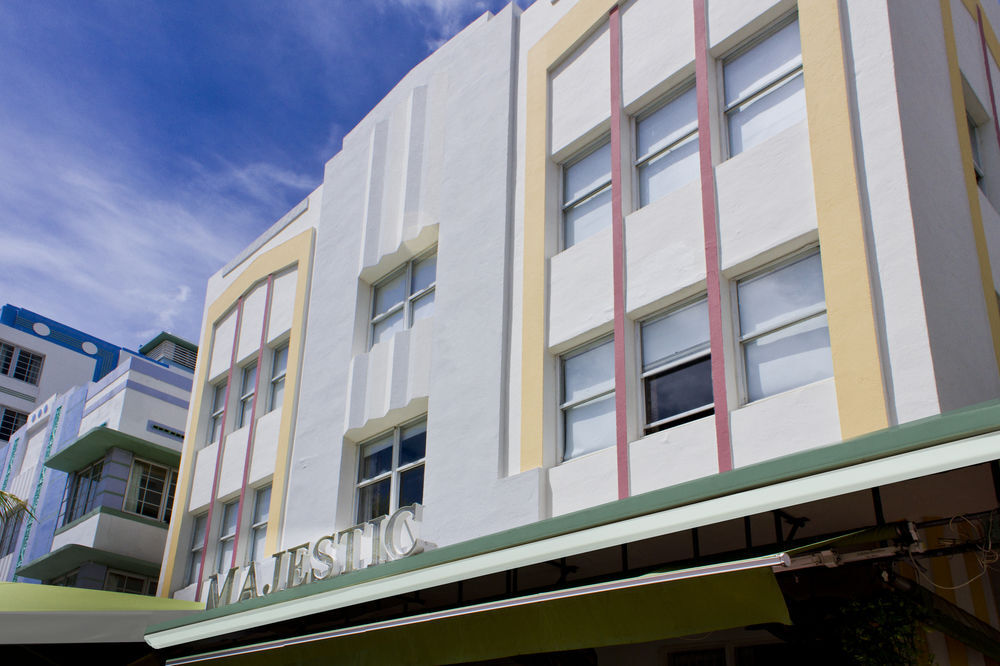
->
[694,0,733,472]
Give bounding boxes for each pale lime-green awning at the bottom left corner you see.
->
[0,583,204,645]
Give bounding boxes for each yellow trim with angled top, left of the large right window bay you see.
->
[521,0,618,471]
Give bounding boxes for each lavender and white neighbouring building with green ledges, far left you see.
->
[0,334,197,594]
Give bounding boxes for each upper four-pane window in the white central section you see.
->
[370,251,437,346]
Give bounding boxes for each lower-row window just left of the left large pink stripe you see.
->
[561,340,615,460]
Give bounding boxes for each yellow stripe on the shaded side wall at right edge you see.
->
[940,0,1000,371]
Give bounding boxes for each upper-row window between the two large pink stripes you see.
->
[635,87,701,207]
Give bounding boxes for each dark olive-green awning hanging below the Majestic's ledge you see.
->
[168,552,791,665]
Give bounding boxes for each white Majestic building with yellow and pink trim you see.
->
[147,0,1000,665]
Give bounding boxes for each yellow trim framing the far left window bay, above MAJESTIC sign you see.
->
[160,229,316,596]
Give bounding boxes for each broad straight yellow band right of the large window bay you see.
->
[799,0,889,439]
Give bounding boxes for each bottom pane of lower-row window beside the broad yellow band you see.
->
[745,313,833,400]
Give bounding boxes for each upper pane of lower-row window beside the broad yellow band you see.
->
[737,254,825,336]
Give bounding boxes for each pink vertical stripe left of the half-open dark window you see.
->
[608,6,630,492]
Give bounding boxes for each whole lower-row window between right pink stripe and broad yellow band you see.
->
[736,252,833,401]
